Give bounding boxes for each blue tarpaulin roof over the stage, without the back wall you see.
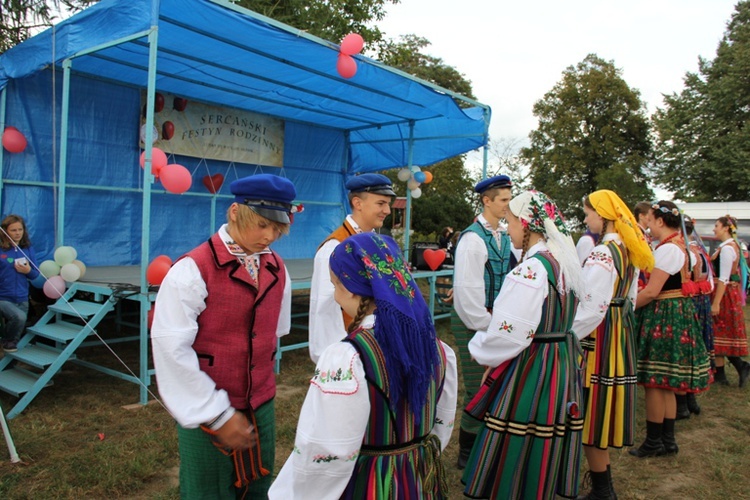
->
[0,0,490,173]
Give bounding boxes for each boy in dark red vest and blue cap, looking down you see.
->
[151,174,296,498]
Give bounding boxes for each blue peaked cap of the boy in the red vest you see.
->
[229,174,297,224]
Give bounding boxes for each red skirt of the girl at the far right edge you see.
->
[714,282,748,356]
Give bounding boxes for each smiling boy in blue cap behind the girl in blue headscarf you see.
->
[308,174,396,363]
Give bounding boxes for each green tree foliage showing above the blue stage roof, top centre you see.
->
[235,0,399,49]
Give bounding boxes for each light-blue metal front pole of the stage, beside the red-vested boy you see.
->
[139,25,159,405]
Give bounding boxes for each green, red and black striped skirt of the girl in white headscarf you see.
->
[462,333,583,499]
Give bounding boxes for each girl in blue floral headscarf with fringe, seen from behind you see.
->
[269,233,458,500]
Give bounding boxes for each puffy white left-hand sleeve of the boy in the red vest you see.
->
[151,257,231,429]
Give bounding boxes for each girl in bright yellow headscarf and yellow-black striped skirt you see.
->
[573,189,654,500]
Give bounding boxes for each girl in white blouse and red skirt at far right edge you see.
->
[711,215,750,387]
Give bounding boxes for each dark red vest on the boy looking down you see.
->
[187,233,286,410]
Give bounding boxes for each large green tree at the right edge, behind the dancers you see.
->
[652,1,750,201]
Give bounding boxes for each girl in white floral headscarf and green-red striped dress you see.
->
[462,191,583,499]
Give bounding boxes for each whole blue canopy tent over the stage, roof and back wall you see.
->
[0,0,490,416]
